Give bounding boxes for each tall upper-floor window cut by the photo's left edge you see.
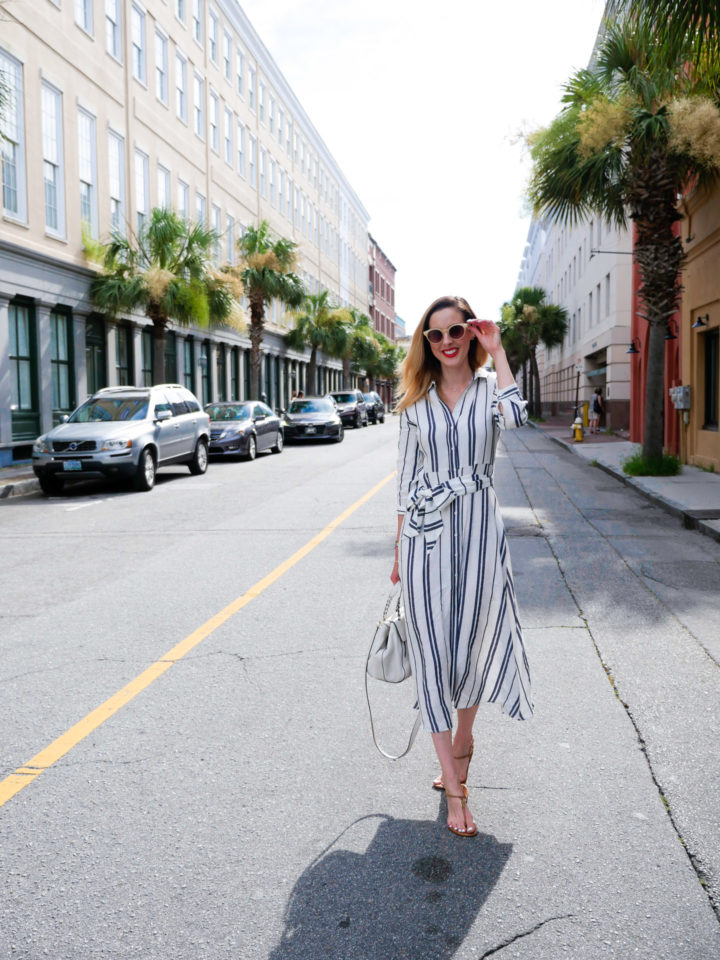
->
[0,50,27,223]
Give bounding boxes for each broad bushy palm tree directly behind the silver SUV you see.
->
[90,208,235,383]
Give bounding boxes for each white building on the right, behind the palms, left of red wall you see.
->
[517,218,632,429]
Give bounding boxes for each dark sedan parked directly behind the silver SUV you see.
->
[205,400,285,460]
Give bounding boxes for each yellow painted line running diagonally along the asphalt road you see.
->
[0,471,395,807]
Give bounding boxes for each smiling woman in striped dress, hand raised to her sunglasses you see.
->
[390,297,532,837]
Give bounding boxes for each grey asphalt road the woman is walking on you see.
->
[0,418,720,960]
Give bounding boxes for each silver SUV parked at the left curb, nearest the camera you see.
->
[33,383,210,495]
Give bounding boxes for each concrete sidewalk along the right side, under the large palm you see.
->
[531,420,720,541]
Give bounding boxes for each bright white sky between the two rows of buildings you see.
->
[240,0,605,331]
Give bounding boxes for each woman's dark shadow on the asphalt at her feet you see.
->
[269,798,512,960]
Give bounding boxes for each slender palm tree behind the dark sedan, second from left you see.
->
[235,220,305,397]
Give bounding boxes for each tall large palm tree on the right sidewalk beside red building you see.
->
[528,19,720,462]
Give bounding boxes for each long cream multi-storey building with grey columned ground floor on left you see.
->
[0,0,369,463]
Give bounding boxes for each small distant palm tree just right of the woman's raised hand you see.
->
[502,287,568,417]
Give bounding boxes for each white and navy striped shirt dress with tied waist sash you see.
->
[398,368,533,733]
